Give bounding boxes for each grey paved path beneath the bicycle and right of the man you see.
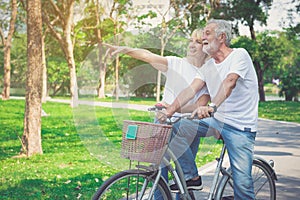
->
[192,119,300,200]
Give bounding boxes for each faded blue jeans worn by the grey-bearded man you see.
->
[169,118,256,200]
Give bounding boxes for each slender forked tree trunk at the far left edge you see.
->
[0,0,18,100]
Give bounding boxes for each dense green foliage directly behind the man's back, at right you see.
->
[232,31,300,101]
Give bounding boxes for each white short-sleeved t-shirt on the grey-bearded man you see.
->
[196,48,259,132]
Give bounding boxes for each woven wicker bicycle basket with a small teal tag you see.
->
[121,120,172,164]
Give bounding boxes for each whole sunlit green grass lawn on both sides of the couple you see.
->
[0,100,300,199]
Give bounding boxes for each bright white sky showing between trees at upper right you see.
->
[240,0,300,36]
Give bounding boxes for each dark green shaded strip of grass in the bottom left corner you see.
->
[0,174,103,200]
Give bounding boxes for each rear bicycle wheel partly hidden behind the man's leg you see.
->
[215,160,276,200]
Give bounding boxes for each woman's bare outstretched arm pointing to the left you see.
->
[103,43,168,72]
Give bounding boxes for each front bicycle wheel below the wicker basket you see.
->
[93,169,172,200]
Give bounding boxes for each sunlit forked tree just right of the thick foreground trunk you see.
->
[43,0,78,107]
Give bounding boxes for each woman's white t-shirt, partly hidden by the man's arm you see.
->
[162,56,208,104]
